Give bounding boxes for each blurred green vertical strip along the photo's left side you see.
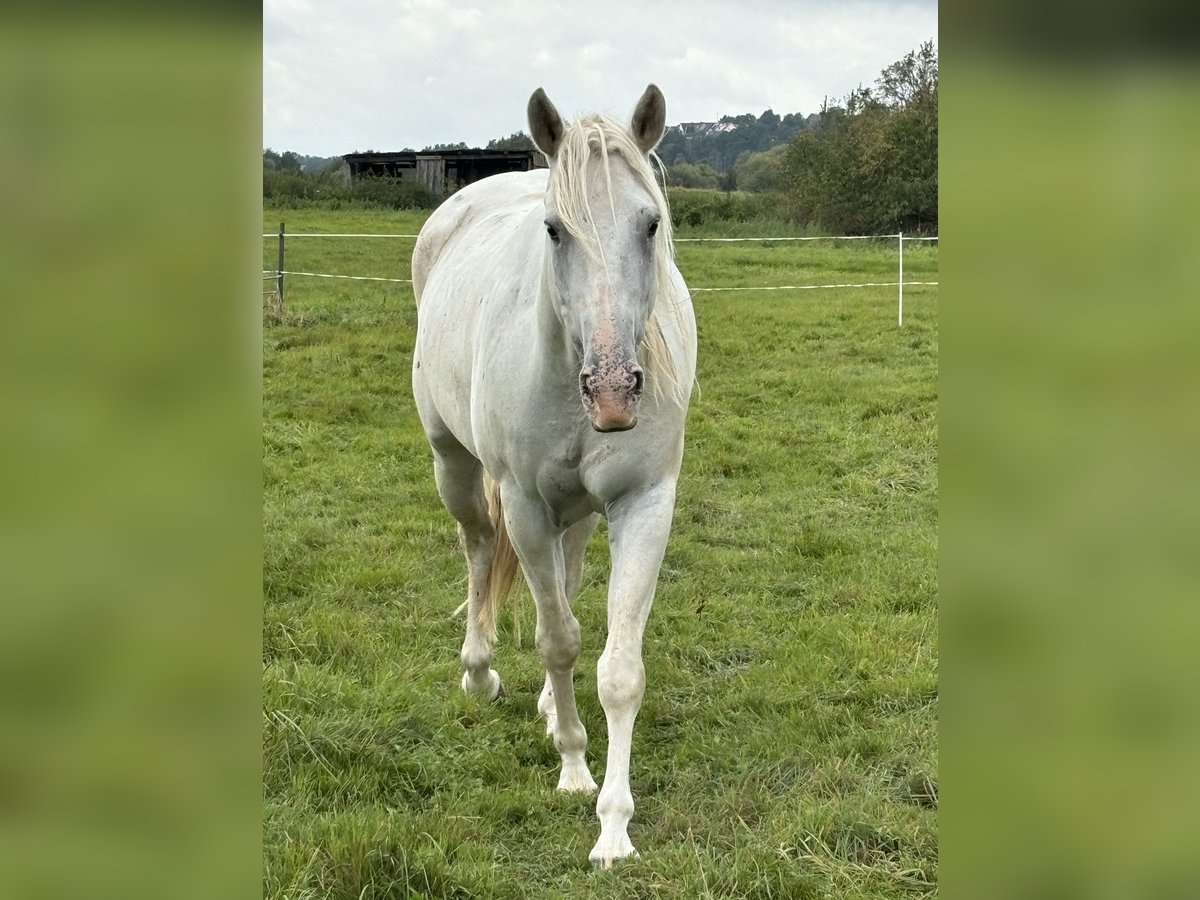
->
[0,6,262,898]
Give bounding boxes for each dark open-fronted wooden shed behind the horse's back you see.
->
[342,150,541,194]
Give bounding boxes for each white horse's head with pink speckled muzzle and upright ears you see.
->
[528,84,671,432]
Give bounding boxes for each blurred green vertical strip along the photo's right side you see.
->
[940,2,1200,898]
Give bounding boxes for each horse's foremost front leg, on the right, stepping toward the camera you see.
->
[588,484,674,869]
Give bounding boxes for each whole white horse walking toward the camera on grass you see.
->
[413,84,696,868]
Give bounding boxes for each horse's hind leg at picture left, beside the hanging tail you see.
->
[433,442,504,700]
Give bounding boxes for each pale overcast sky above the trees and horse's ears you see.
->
[263,0,937,156]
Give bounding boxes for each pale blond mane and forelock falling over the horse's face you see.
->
[547,113,691,406]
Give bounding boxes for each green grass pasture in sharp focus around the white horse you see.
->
[263,204,938,899]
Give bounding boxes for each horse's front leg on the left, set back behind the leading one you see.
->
[502,491,596,793]
